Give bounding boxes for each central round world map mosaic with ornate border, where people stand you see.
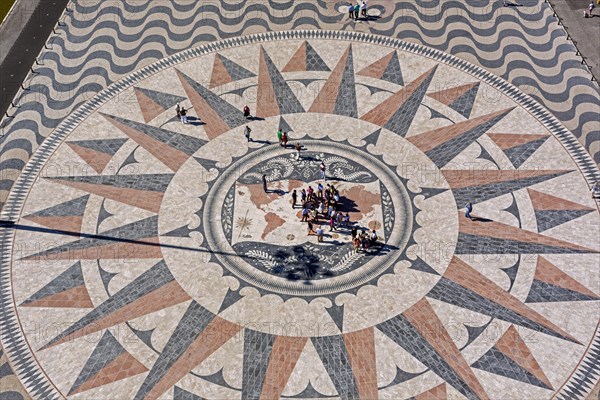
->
[204,140,413,295]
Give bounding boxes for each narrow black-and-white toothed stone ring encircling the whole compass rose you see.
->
[0,30,600,398]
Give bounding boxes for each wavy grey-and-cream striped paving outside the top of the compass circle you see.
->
[0,0,600,206]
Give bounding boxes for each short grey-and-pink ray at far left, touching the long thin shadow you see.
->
[23,194,90,232]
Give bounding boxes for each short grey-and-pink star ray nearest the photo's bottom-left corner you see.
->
[68,330,148,396]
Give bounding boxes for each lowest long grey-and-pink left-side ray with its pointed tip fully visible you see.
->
[42,261,190,349]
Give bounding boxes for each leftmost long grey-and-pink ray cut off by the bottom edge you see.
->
[134,300,242,400]
